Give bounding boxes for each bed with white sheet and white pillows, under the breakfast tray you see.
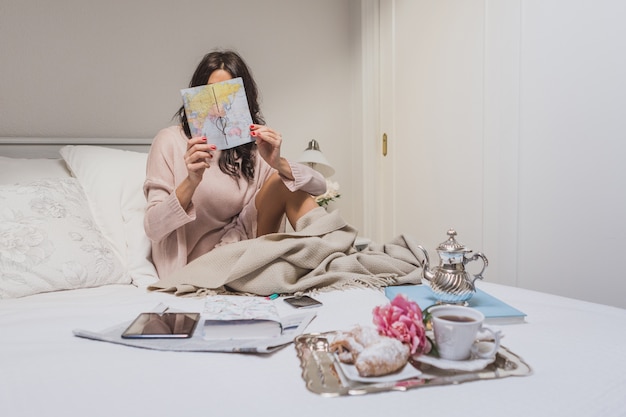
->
[0,139,626,417]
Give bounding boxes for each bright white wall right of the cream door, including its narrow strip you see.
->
[484,0,626,307]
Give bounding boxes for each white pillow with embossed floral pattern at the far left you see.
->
[0,178,131,298]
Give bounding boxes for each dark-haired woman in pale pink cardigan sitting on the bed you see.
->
[144,51,326,278]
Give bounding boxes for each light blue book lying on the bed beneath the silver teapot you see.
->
[385,284,526,324]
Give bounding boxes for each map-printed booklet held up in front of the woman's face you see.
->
[180,77,253,149]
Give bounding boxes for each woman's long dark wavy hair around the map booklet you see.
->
[174,51,265,181]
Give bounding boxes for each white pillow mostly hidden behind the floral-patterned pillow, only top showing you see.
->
[0,156,71,184]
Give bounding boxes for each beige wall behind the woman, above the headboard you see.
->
[0,0,361,227]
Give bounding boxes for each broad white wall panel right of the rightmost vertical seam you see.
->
[518,0,626,307]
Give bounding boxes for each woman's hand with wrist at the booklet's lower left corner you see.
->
[176,136,217,210]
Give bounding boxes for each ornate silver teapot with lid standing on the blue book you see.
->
[418,229,489,304]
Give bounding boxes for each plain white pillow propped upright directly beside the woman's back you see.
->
[60,145,158,286]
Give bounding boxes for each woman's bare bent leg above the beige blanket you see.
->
[256,174,318,236]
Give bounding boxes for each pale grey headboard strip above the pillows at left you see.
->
[0,137,152,158]
